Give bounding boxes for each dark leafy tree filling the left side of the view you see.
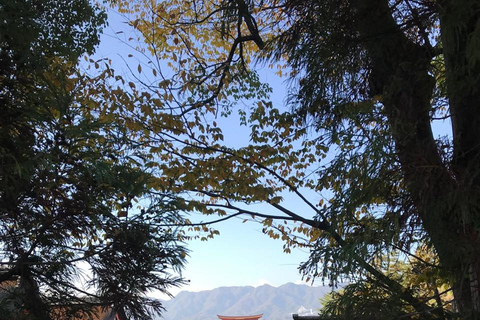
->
[0,0,187,319]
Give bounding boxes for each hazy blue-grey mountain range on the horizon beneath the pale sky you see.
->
[159,283,331,320]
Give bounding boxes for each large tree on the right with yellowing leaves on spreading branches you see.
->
[108,0,480,319]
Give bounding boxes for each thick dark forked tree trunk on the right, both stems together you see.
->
[351,0,480,317]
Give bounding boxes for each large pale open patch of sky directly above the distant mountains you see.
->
[179,218,308,291]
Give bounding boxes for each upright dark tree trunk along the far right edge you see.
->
[439,0,480,319]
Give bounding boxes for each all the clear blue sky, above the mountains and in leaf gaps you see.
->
[91,6,321,298]
